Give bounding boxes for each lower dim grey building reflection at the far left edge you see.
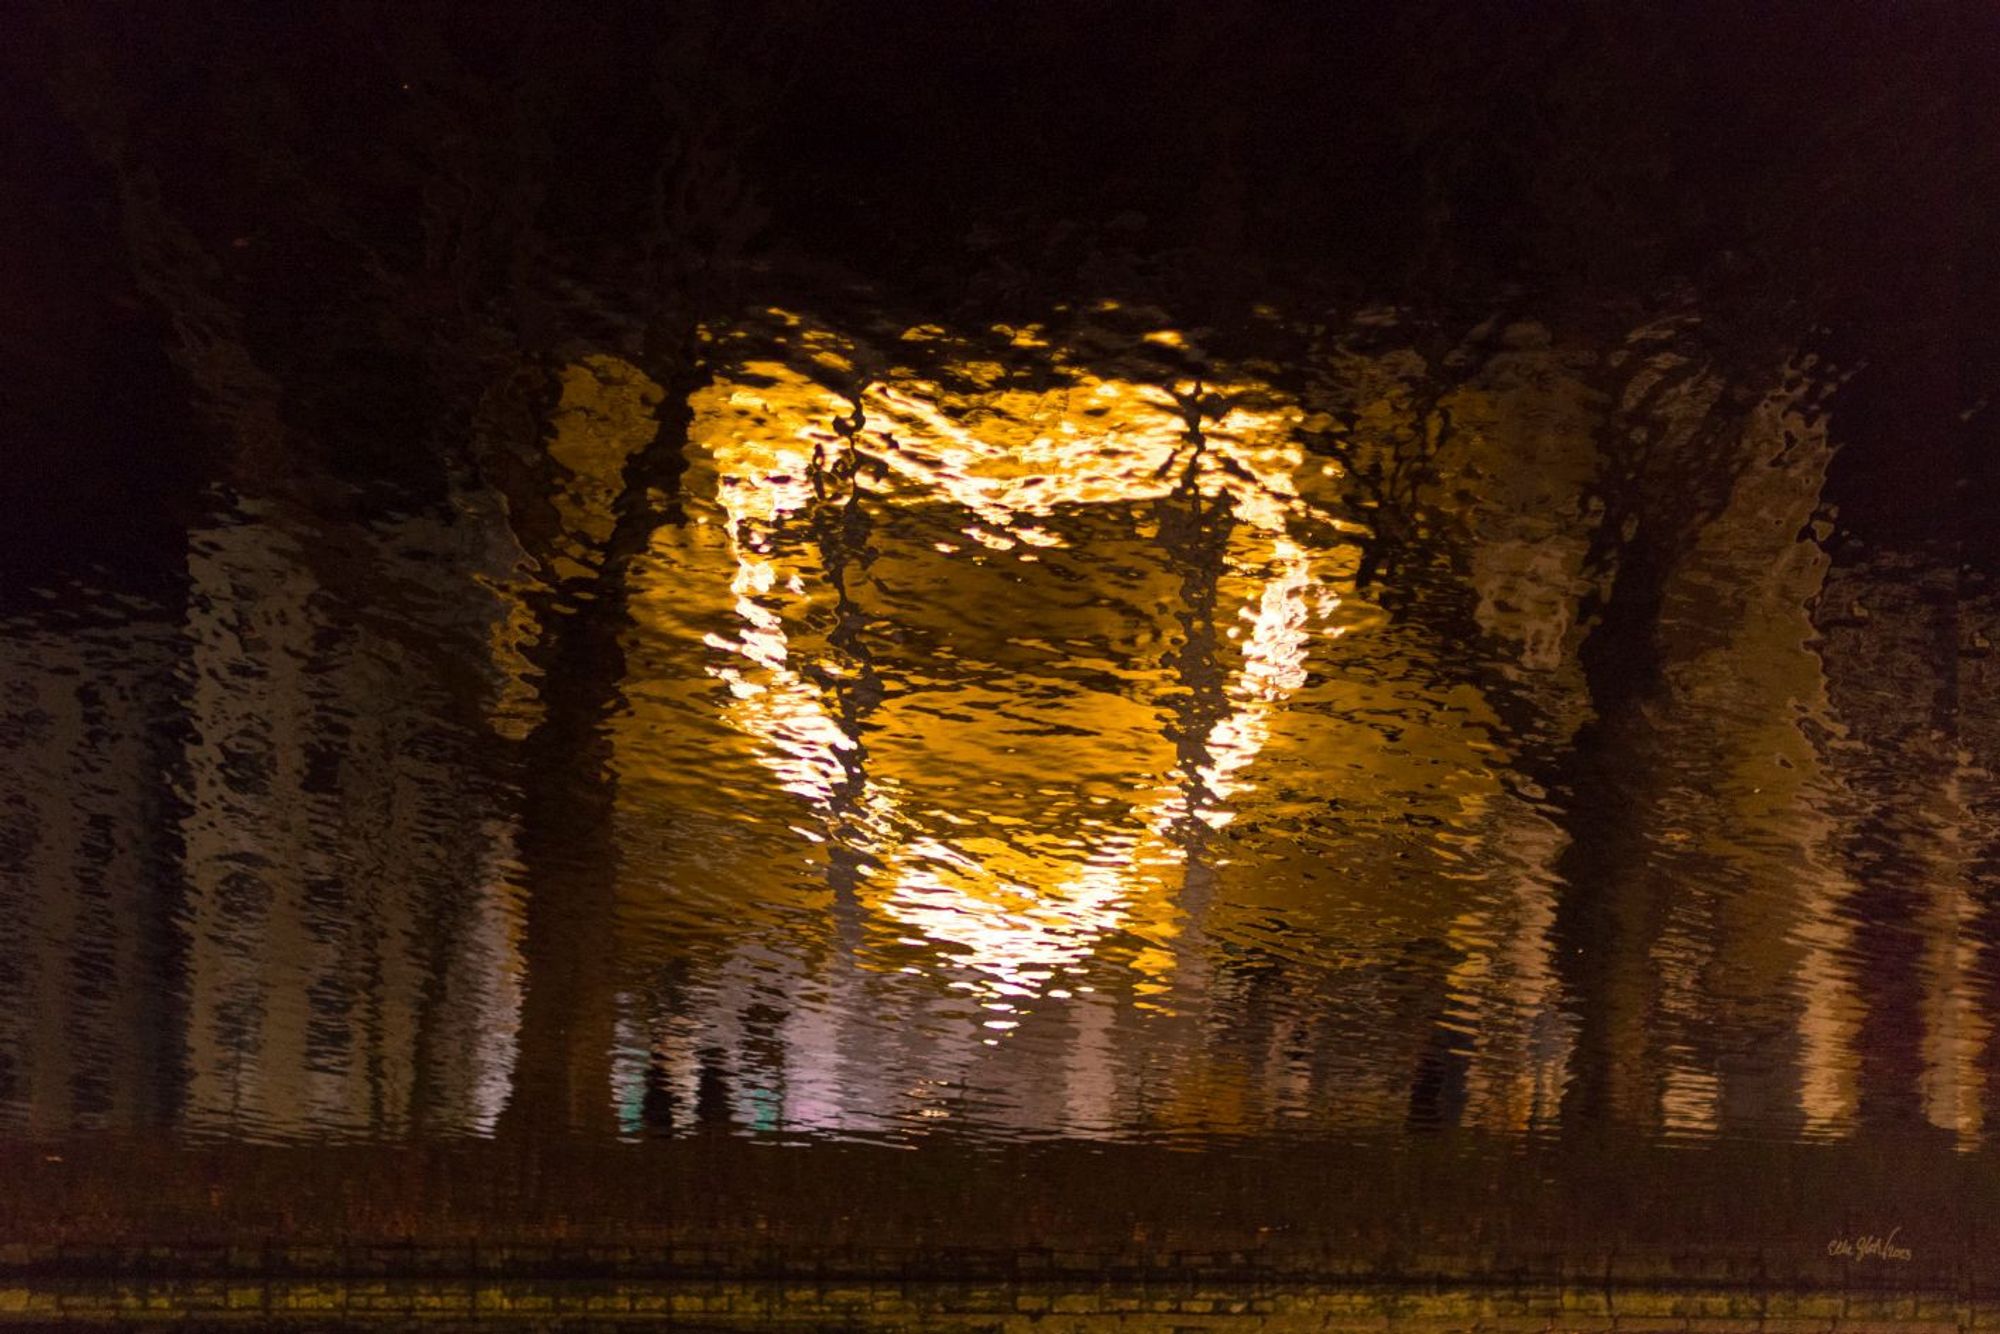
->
[0,604,176,1134]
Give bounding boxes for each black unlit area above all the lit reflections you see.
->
[0,0,2000,584]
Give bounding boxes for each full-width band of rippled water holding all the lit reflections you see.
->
[0,302,2000,1146]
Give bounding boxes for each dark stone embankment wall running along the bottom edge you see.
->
[0,1136,2000,1332]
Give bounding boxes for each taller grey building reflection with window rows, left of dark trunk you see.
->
[182,504,518,1136]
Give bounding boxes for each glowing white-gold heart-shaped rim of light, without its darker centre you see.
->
[692,318,1344,1016]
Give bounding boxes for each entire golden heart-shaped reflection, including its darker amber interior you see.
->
[636,320,1352,1016]
